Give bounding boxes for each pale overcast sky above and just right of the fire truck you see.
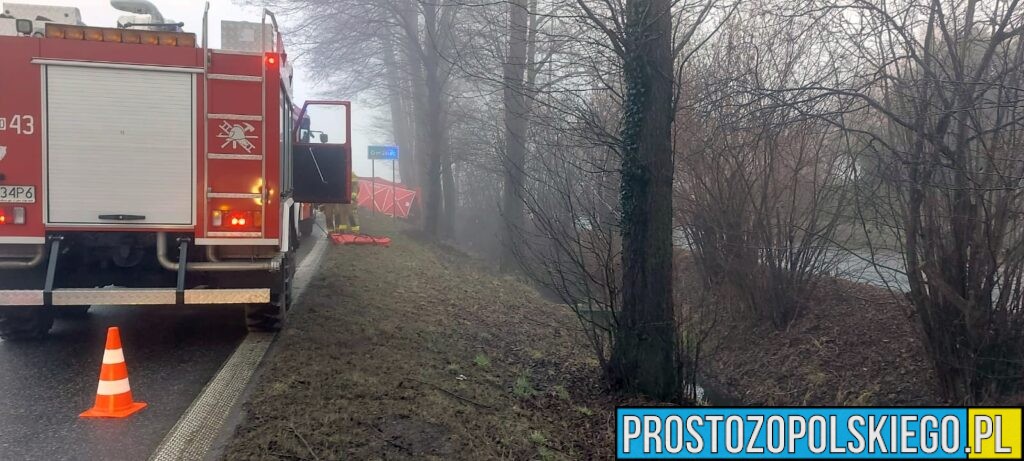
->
[8,0,391,179]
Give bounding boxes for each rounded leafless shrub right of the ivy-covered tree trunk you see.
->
[677,13,850,328]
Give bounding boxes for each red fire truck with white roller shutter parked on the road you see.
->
[0,0,351,339]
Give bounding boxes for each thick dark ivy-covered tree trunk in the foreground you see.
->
[609,0,680,401]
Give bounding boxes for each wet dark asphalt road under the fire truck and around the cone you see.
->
[0,227,323,460]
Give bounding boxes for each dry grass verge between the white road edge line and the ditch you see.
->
[225,219,615,460]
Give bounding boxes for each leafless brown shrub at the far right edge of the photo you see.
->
[794,0,1024,404]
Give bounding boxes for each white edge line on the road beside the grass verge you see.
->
[150,235,328,461]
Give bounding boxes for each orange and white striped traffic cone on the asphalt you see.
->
[79,327,145,418]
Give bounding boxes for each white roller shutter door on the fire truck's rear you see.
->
[45,66,196,226]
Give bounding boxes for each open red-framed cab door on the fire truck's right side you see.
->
[292,100,352,204]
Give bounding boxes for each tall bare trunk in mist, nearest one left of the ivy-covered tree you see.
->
[501,0,529,271]
